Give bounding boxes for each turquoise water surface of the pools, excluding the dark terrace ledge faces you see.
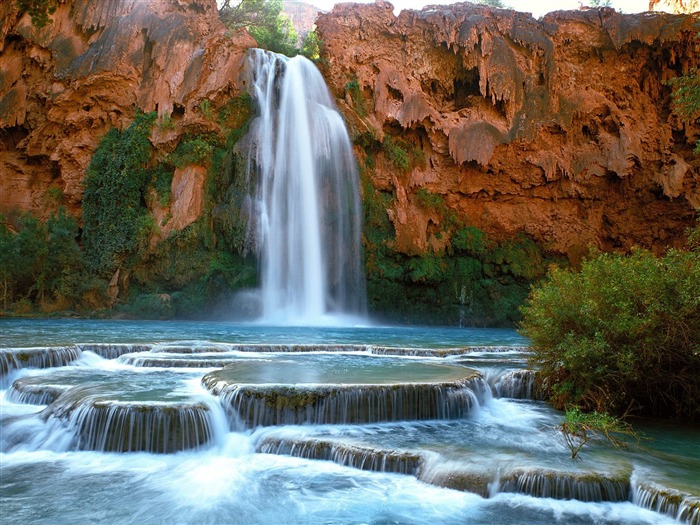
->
[0,320,700,525]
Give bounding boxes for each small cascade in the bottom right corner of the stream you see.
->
[632,480,700,525]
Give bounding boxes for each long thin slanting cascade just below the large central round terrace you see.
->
[256,437,423,476]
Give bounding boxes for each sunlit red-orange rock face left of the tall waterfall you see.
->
[0,0,254,220]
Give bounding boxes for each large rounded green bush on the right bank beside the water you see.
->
[521,237,700,419]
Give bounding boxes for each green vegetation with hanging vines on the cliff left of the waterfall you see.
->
[0,95,256,318]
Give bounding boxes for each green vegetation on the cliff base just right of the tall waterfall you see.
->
[363,168,547,326]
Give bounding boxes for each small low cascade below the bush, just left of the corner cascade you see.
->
[492,469,630,502]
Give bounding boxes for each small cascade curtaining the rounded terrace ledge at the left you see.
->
[44,387,214,453]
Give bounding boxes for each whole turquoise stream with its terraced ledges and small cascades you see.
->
[0,320,700,525]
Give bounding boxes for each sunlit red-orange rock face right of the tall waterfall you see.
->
[318,2,700,260]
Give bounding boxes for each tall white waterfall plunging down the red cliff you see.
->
[242,49,365,324]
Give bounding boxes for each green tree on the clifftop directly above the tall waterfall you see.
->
[219,0,299,56]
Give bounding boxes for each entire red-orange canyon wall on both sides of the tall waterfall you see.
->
[0,0,700,266]
